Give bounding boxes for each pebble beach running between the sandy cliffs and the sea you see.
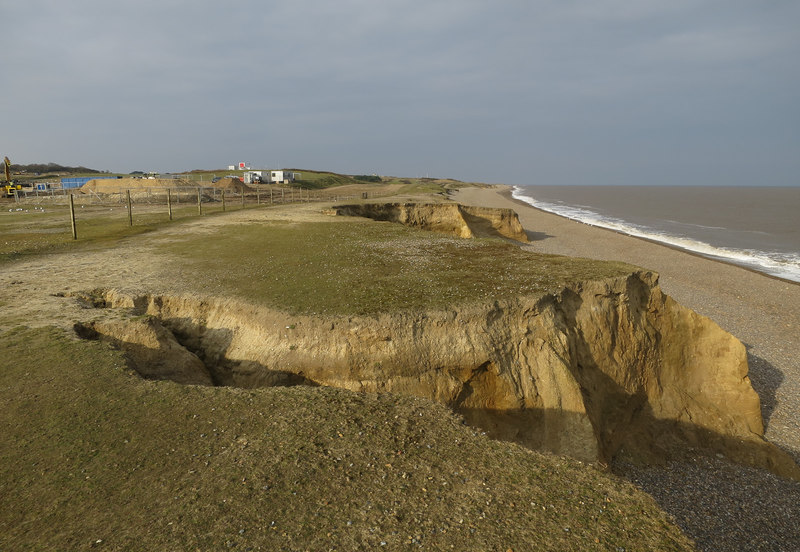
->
[451,186,800,552]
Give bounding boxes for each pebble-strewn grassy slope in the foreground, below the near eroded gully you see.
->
[0,328,691,552]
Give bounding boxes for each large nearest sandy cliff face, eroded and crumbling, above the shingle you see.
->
[83,272,800,478]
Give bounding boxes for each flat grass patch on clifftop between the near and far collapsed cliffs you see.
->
[161,218,634,314]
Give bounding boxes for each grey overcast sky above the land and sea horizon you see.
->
[0,0,800,185]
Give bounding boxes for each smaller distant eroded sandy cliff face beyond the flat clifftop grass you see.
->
[333,203,528,243]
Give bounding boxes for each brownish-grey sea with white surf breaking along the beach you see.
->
[513,186,800,282]
